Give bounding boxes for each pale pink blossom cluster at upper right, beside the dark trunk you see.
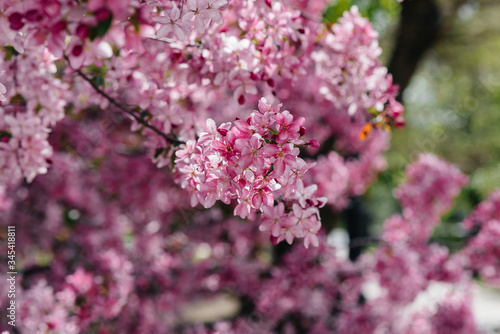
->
[312,6,403,124]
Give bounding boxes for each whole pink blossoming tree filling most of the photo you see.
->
[0,0,500,333]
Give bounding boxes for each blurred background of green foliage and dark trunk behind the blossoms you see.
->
[324,0,500,333]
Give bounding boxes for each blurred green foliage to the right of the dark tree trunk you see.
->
[356,0,500,245]
